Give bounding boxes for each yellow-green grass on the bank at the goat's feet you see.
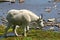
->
[0,26,60,40]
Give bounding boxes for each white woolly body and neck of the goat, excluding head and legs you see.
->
[6,9,39,24]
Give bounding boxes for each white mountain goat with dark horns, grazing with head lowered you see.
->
[5,9,44,36]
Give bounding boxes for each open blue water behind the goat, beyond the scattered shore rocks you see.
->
[0,0,60,30]
